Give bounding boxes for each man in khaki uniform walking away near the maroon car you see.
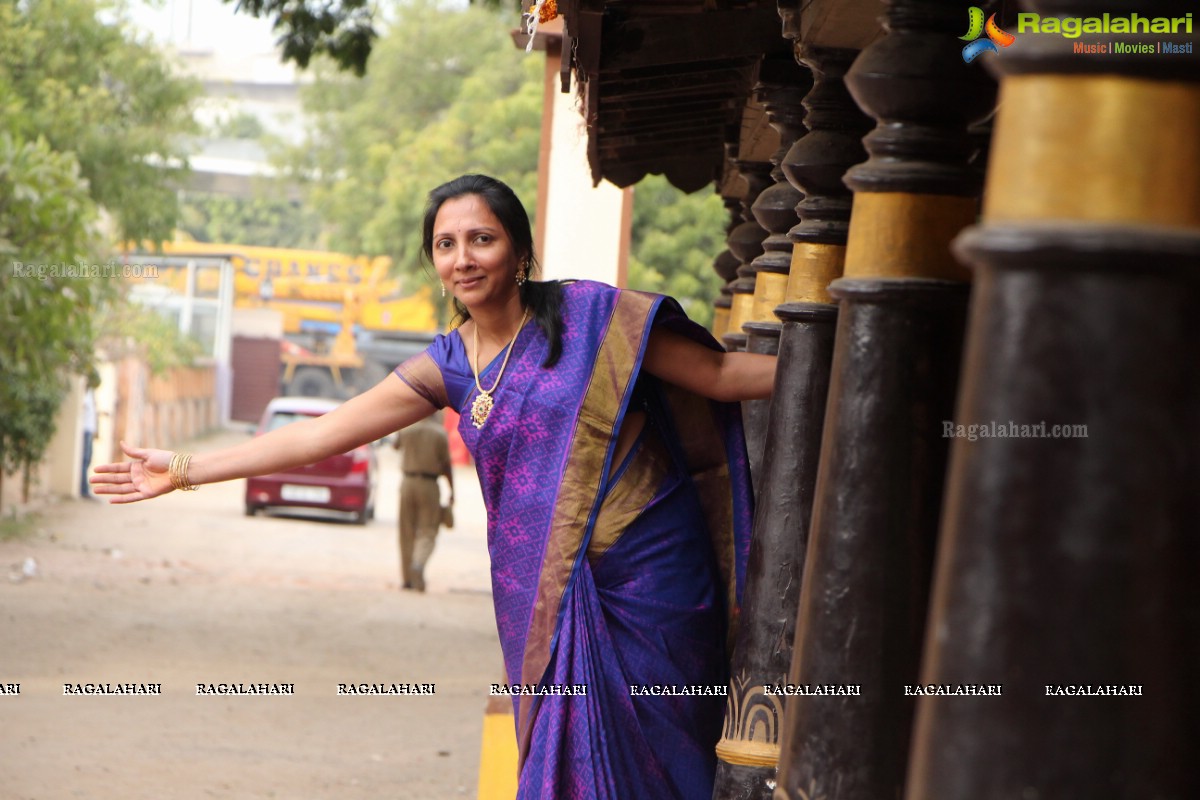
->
[395,413,454,591]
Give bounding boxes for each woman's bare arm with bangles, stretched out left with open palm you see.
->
[91,374,434,503]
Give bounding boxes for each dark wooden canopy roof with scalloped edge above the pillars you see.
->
[558,0,882,192]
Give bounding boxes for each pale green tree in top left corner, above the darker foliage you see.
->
[0,0,198,241]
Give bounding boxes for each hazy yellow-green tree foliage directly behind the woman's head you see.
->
[289,0,542,273]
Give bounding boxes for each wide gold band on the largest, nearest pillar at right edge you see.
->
[984,74,1200,228]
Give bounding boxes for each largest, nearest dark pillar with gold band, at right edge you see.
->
[907,0,1200,800]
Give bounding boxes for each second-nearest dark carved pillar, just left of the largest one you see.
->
[775,0,994,800]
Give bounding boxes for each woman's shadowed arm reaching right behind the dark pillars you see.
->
[642,330,775,402]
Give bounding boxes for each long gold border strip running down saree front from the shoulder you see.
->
[508,291,656,769]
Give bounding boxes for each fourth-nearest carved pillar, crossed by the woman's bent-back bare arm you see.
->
[742,55,812,497]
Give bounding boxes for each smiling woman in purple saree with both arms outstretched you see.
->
[92,175,774,800]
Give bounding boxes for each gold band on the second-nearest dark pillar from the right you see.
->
[845,192,979,282]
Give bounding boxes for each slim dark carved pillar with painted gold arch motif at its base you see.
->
[713,42,870,800]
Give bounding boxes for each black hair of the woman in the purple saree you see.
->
[421,175,563,367]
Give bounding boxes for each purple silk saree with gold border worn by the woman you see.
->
[396,282,752,800]
